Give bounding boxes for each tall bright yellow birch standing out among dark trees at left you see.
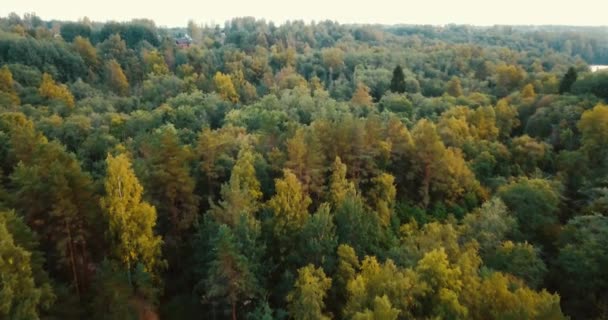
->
[100,154,163,282]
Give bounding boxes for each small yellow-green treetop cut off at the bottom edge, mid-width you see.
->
[287,264,331,320]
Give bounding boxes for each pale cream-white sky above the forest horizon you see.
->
[0,0,608,27]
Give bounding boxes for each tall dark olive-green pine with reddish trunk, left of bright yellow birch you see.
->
[11,141,96,297]
